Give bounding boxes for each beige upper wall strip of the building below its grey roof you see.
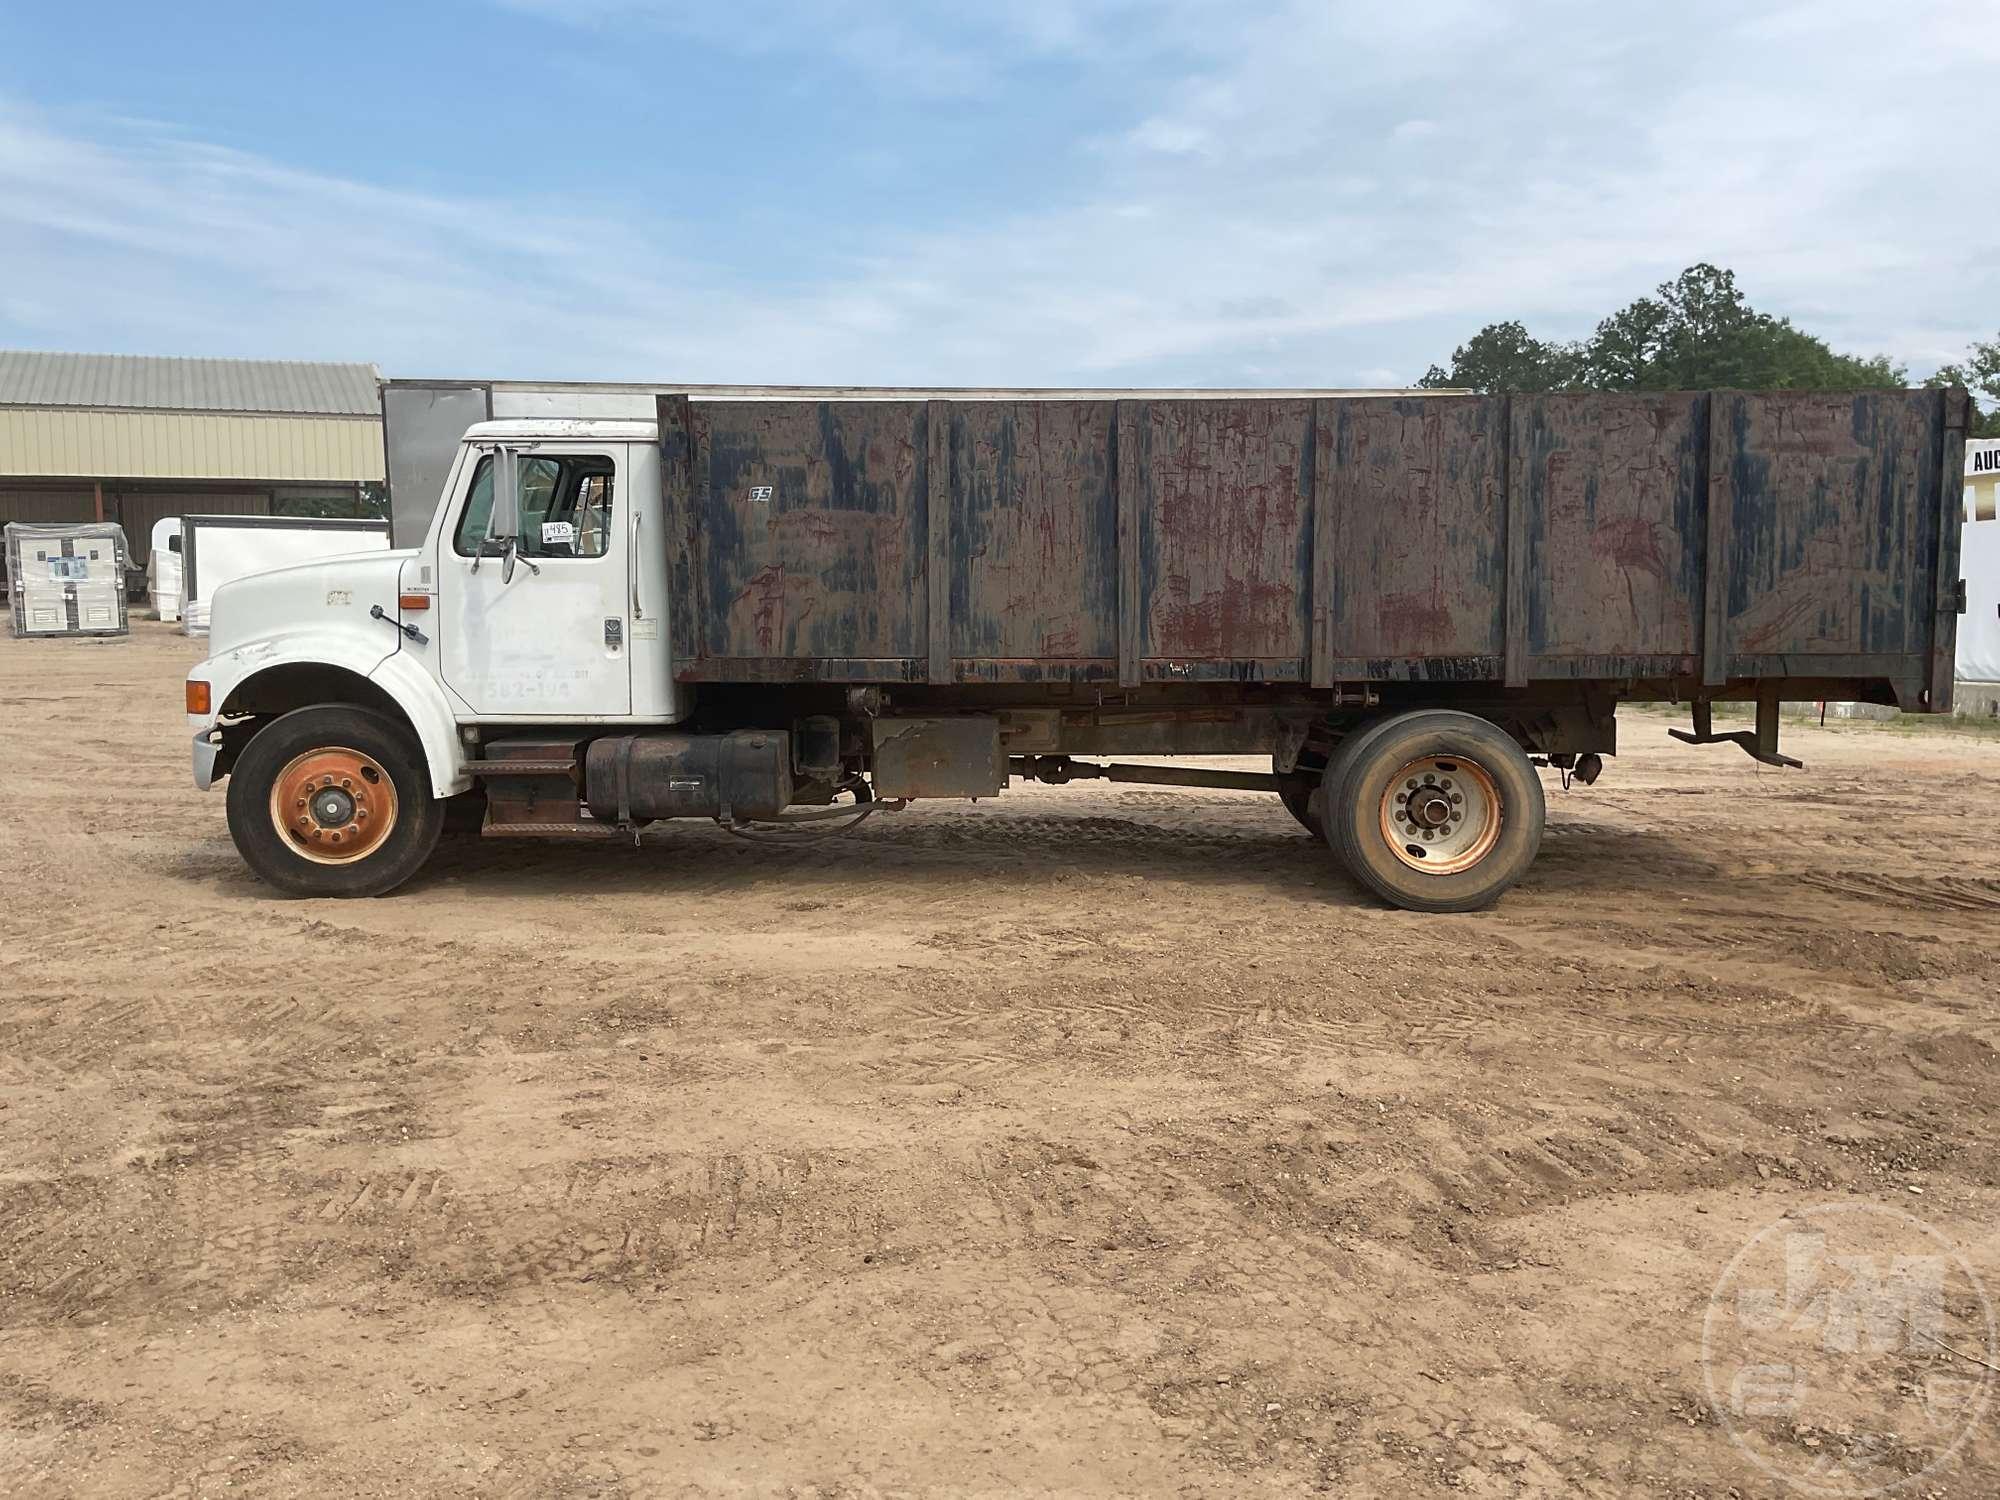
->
[0,406,384,484]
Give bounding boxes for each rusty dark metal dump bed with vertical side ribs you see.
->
[658,390,1966,710]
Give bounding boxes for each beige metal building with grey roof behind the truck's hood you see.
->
[0,350,384,576]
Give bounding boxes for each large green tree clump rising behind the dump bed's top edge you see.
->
[1422,264,1904,392]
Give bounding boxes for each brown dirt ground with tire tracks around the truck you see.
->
[0,622,2000,1496]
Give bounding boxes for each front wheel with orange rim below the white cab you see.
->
[228,706,444,896]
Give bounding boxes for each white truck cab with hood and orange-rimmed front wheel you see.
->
[188,418,684,894]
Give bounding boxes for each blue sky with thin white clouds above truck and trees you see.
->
[0,0,2000,386]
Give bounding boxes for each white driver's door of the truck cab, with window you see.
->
[436,442,632,720]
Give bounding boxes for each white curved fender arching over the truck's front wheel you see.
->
[188,622,472,798]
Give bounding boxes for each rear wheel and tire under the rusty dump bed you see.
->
[1326,710,1546,912]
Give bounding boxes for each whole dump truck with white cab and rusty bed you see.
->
[186,390,1970,912]
